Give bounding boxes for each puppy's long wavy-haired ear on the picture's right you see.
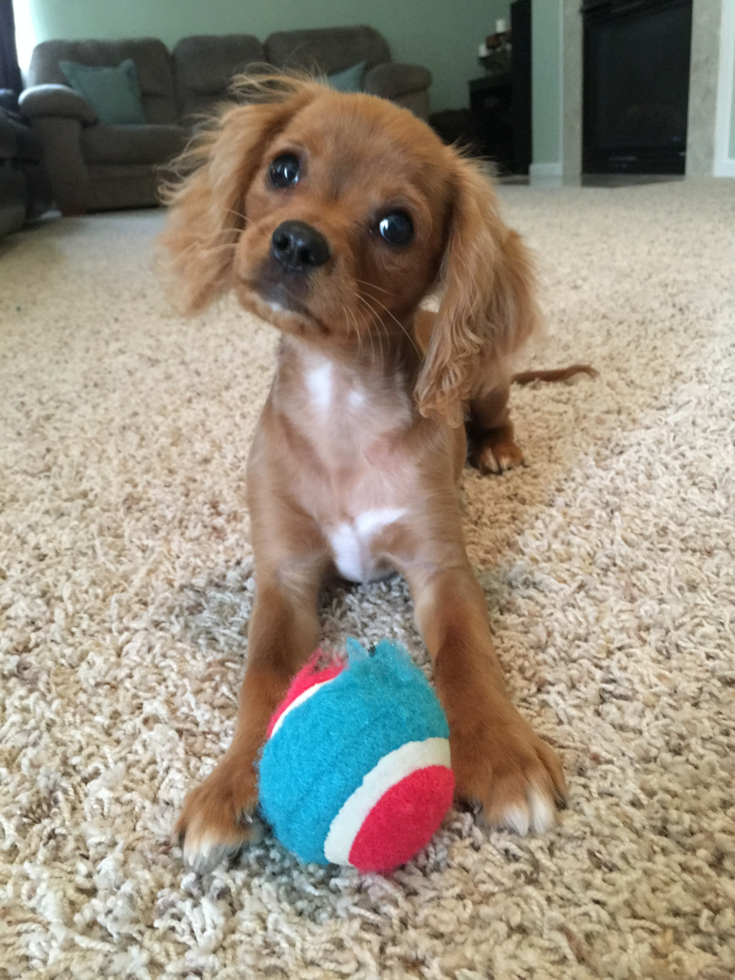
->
[416,157,540,426]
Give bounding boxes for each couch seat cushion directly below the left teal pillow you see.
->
[82,125,189,163]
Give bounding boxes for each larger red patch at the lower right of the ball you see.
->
[350,766,454,871]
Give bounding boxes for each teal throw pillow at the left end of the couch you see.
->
[59,58,145,126]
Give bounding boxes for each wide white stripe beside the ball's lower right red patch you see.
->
[324,738,452,864]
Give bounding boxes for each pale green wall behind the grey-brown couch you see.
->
[14,0,510,111]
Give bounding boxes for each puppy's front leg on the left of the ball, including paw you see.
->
[176,558,322,873]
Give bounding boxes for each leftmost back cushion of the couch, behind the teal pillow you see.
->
[28,38,177,124]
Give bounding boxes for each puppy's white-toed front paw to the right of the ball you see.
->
[450,705,566,835]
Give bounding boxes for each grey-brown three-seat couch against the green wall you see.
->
[20,27,431,214]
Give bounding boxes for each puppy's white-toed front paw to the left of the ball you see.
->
[176,756,263,874]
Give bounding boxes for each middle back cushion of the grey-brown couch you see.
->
[173,34,265,122]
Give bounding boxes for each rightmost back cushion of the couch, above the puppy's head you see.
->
[265,27,390,75]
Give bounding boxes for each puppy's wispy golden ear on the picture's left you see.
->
[159,78,318,315]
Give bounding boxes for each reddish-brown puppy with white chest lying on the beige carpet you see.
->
[162,77,565,871]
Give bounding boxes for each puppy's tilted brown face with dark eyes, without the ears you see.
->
[232,90,451,344]
